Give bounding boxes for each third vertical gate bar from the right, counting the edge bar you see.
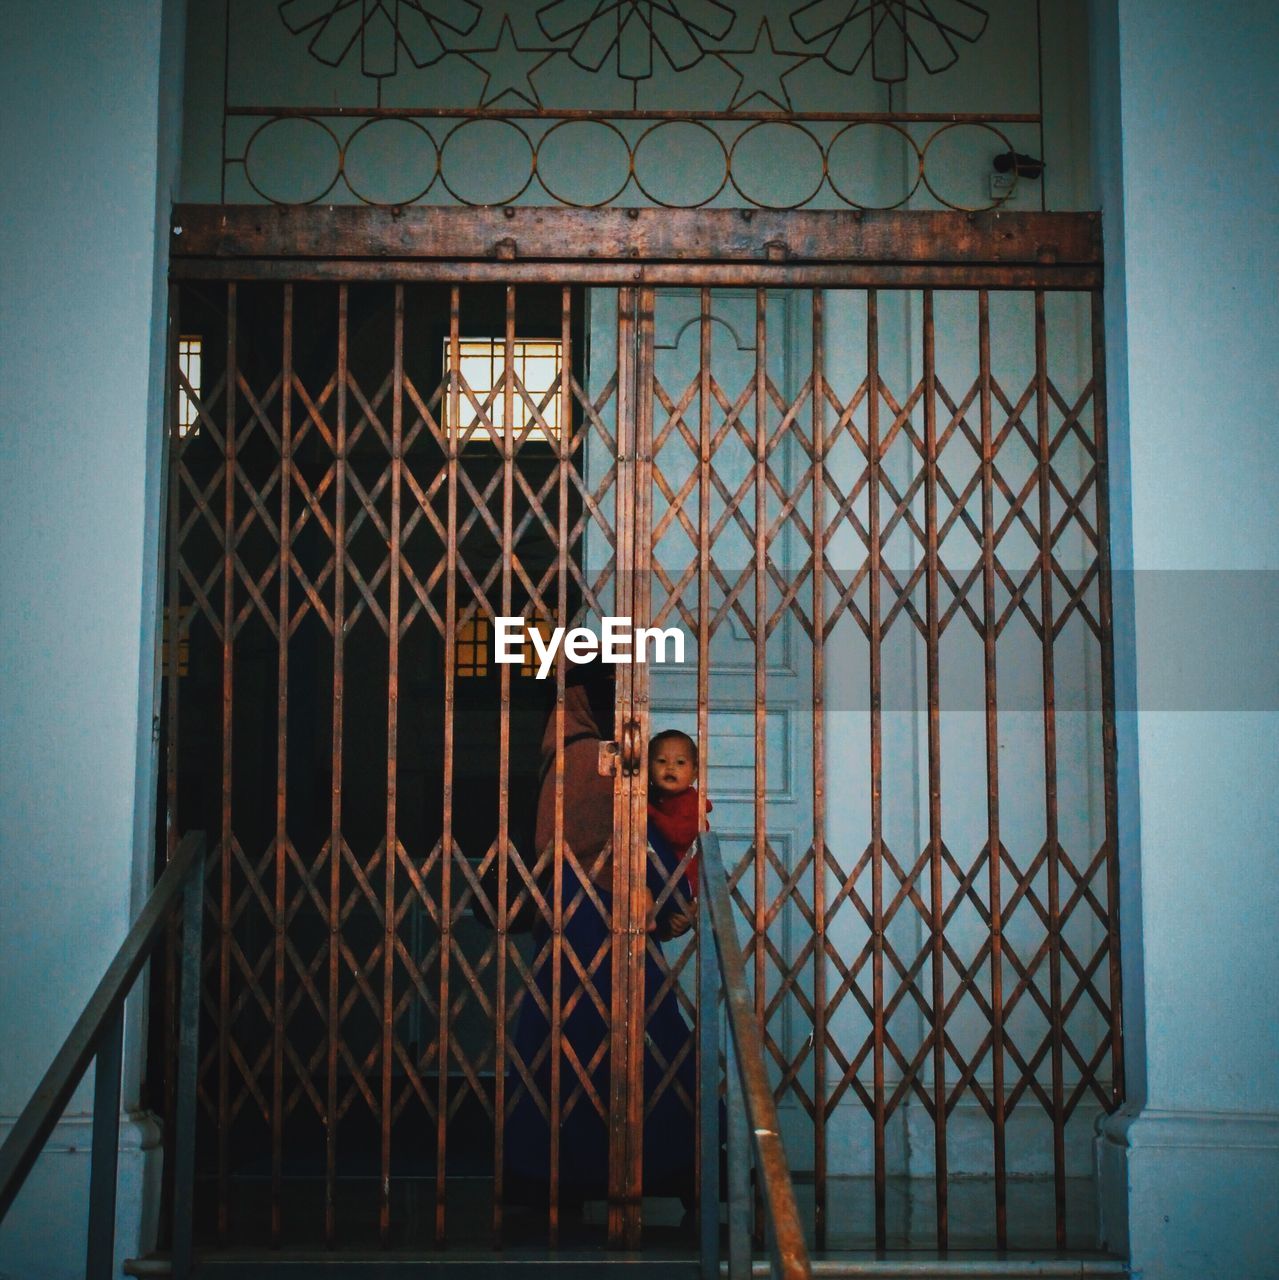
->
[977,289,1008,1249]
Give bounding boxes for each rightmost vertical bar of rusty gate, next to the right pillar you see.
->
[1091,289,1124,1107]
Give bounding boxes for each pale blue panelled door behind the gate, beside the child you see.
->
[648,289,813,1208]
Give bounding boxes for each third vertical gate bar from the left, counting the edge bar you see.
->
[271,284,293,1245]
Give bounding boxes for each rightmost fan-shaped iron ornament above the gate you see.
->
[790,0,990,84]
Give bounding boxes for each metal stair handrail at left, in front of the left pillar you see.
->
[0,832,209,1277]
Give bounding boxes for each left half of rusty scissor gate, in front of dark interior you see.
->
[163,284,650,1243]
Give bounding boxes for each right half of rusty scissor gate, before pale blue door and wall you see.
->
[639,289,1123,1248]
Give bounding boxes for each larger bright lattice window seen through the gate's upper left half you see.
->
[444,338,561,443]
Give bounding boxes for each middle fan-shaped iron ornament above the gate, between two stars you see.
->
[538,0,736,81]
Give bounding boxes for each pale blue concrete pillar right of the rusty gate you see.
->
[1093,0,1279,1280]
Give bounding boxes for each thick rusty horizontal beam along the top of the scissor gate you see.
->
[170,205,1102,288]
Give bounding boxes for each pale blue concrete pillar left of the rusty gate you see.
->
[0,0,186,1280]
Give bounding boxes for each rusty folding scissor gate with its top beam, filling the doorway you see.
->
[163,207,1123,1247]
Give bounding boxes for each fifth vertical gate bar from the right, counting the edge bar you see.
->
[865,289,889,1249]
